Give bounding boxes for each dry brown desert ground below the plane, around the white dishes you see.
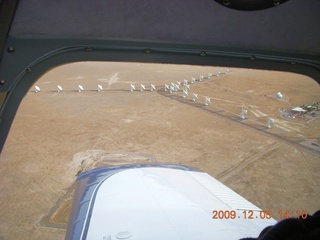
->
[0,62,320,240]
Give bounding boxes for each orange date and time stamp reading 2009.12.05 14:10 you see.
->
[212,210,308,219]
